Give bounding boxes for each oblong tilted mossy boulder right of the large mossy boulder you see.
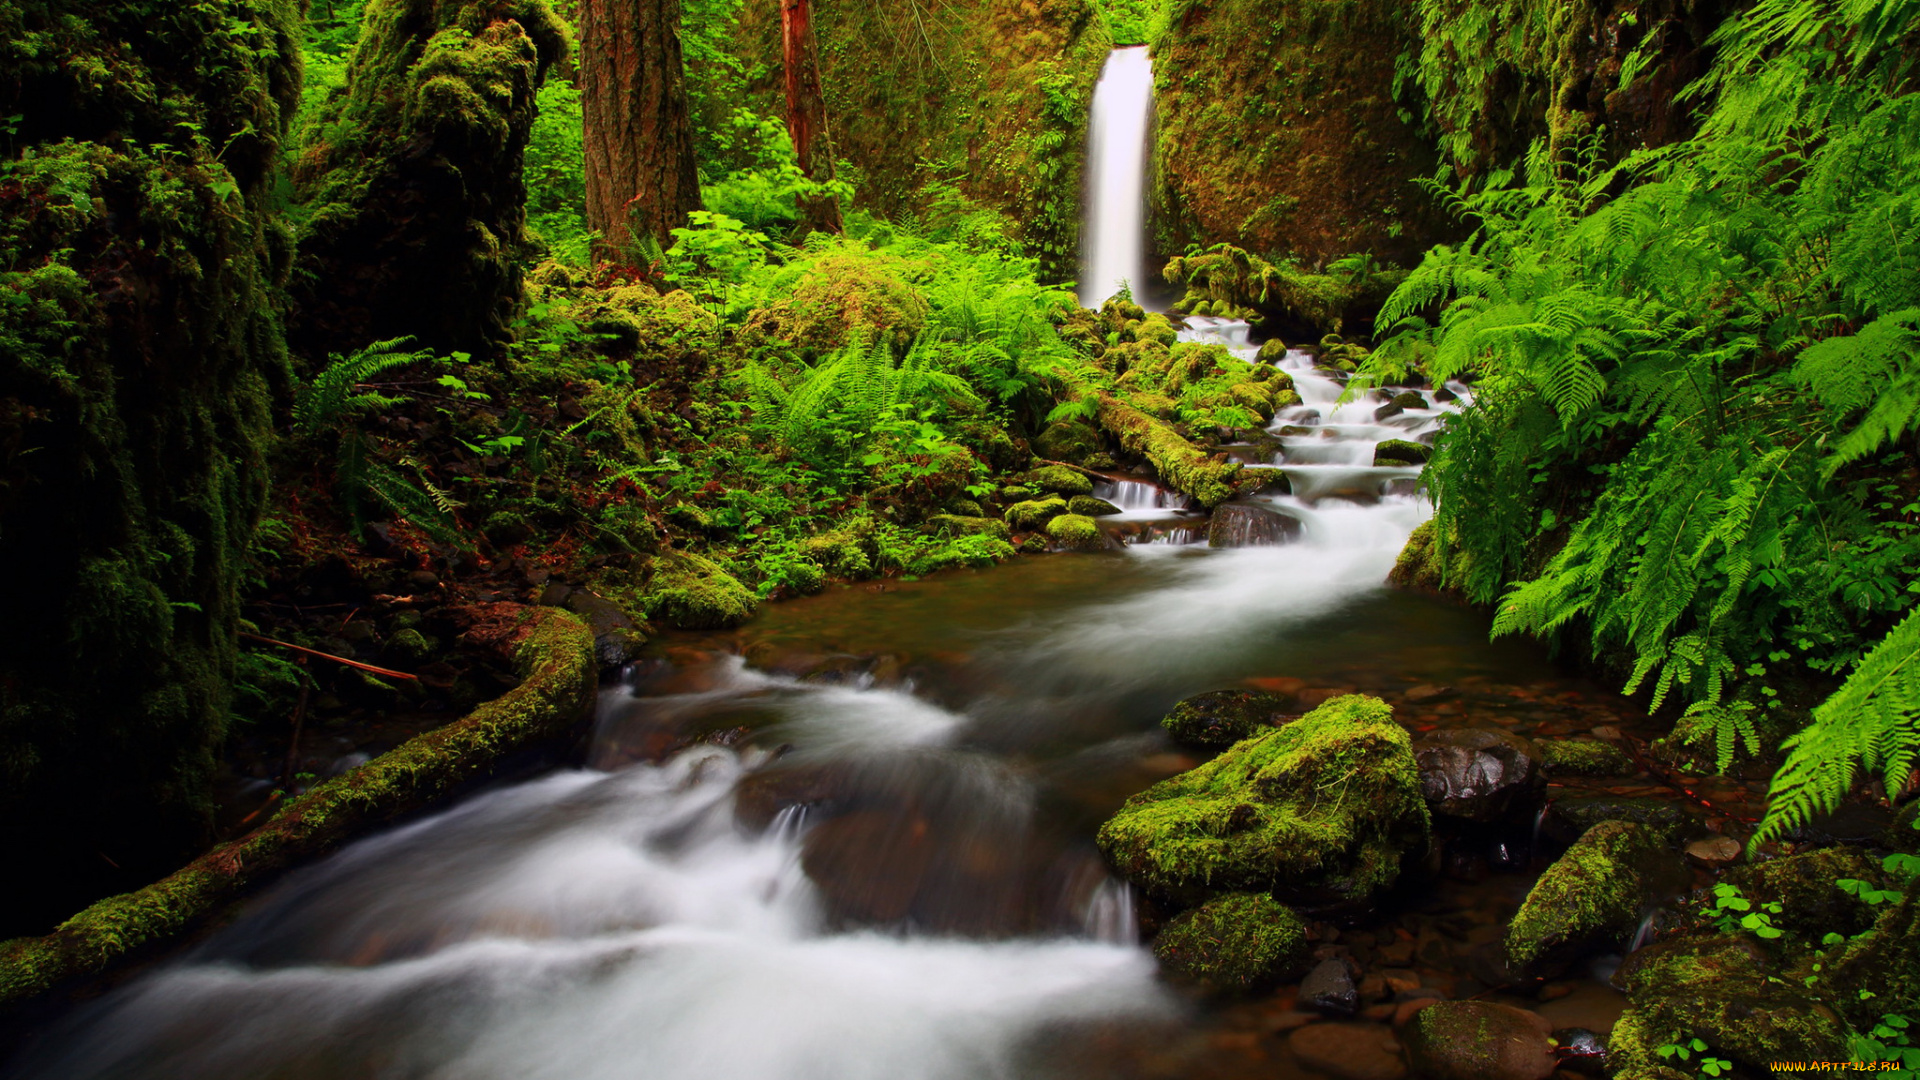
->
[1507,821,1665,972]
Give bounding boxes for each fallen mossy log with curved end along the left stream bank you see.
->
[0,603,599,1005]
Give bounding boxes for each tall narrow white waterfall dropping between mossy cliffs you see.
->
[1081,46,1154,307]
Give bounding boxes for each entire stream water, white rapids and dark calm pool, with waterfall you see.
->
[12,50,1766,1080]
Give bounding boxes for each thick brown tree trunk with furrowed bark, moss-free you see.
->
[580,0,701,261]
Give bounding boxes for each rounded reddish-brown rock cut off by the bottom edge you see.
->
[1400,1001,1559,1080]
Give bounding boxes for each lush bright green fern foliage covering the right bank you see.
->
[1361,0,1920,799]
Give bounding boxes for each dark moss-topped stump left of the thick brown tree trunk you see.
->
[294,0,572,356]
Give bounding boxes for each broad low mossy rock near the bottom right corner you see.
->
[1607,934,1847,1076]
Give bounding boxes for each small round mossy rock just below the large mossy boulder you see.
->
[1154,892,1311,992]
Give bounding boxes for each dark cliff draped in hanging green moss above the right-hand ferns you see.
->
[1402,0,1738,173]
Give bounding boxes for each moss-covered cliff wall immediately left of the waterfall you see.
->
[721,0,1110,279]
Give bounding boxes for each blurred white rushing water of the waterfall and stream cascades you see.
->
[15,50,1465,1080]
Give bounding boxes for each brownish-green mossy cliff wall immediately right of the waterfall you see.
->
[1152,0,1453,269]
